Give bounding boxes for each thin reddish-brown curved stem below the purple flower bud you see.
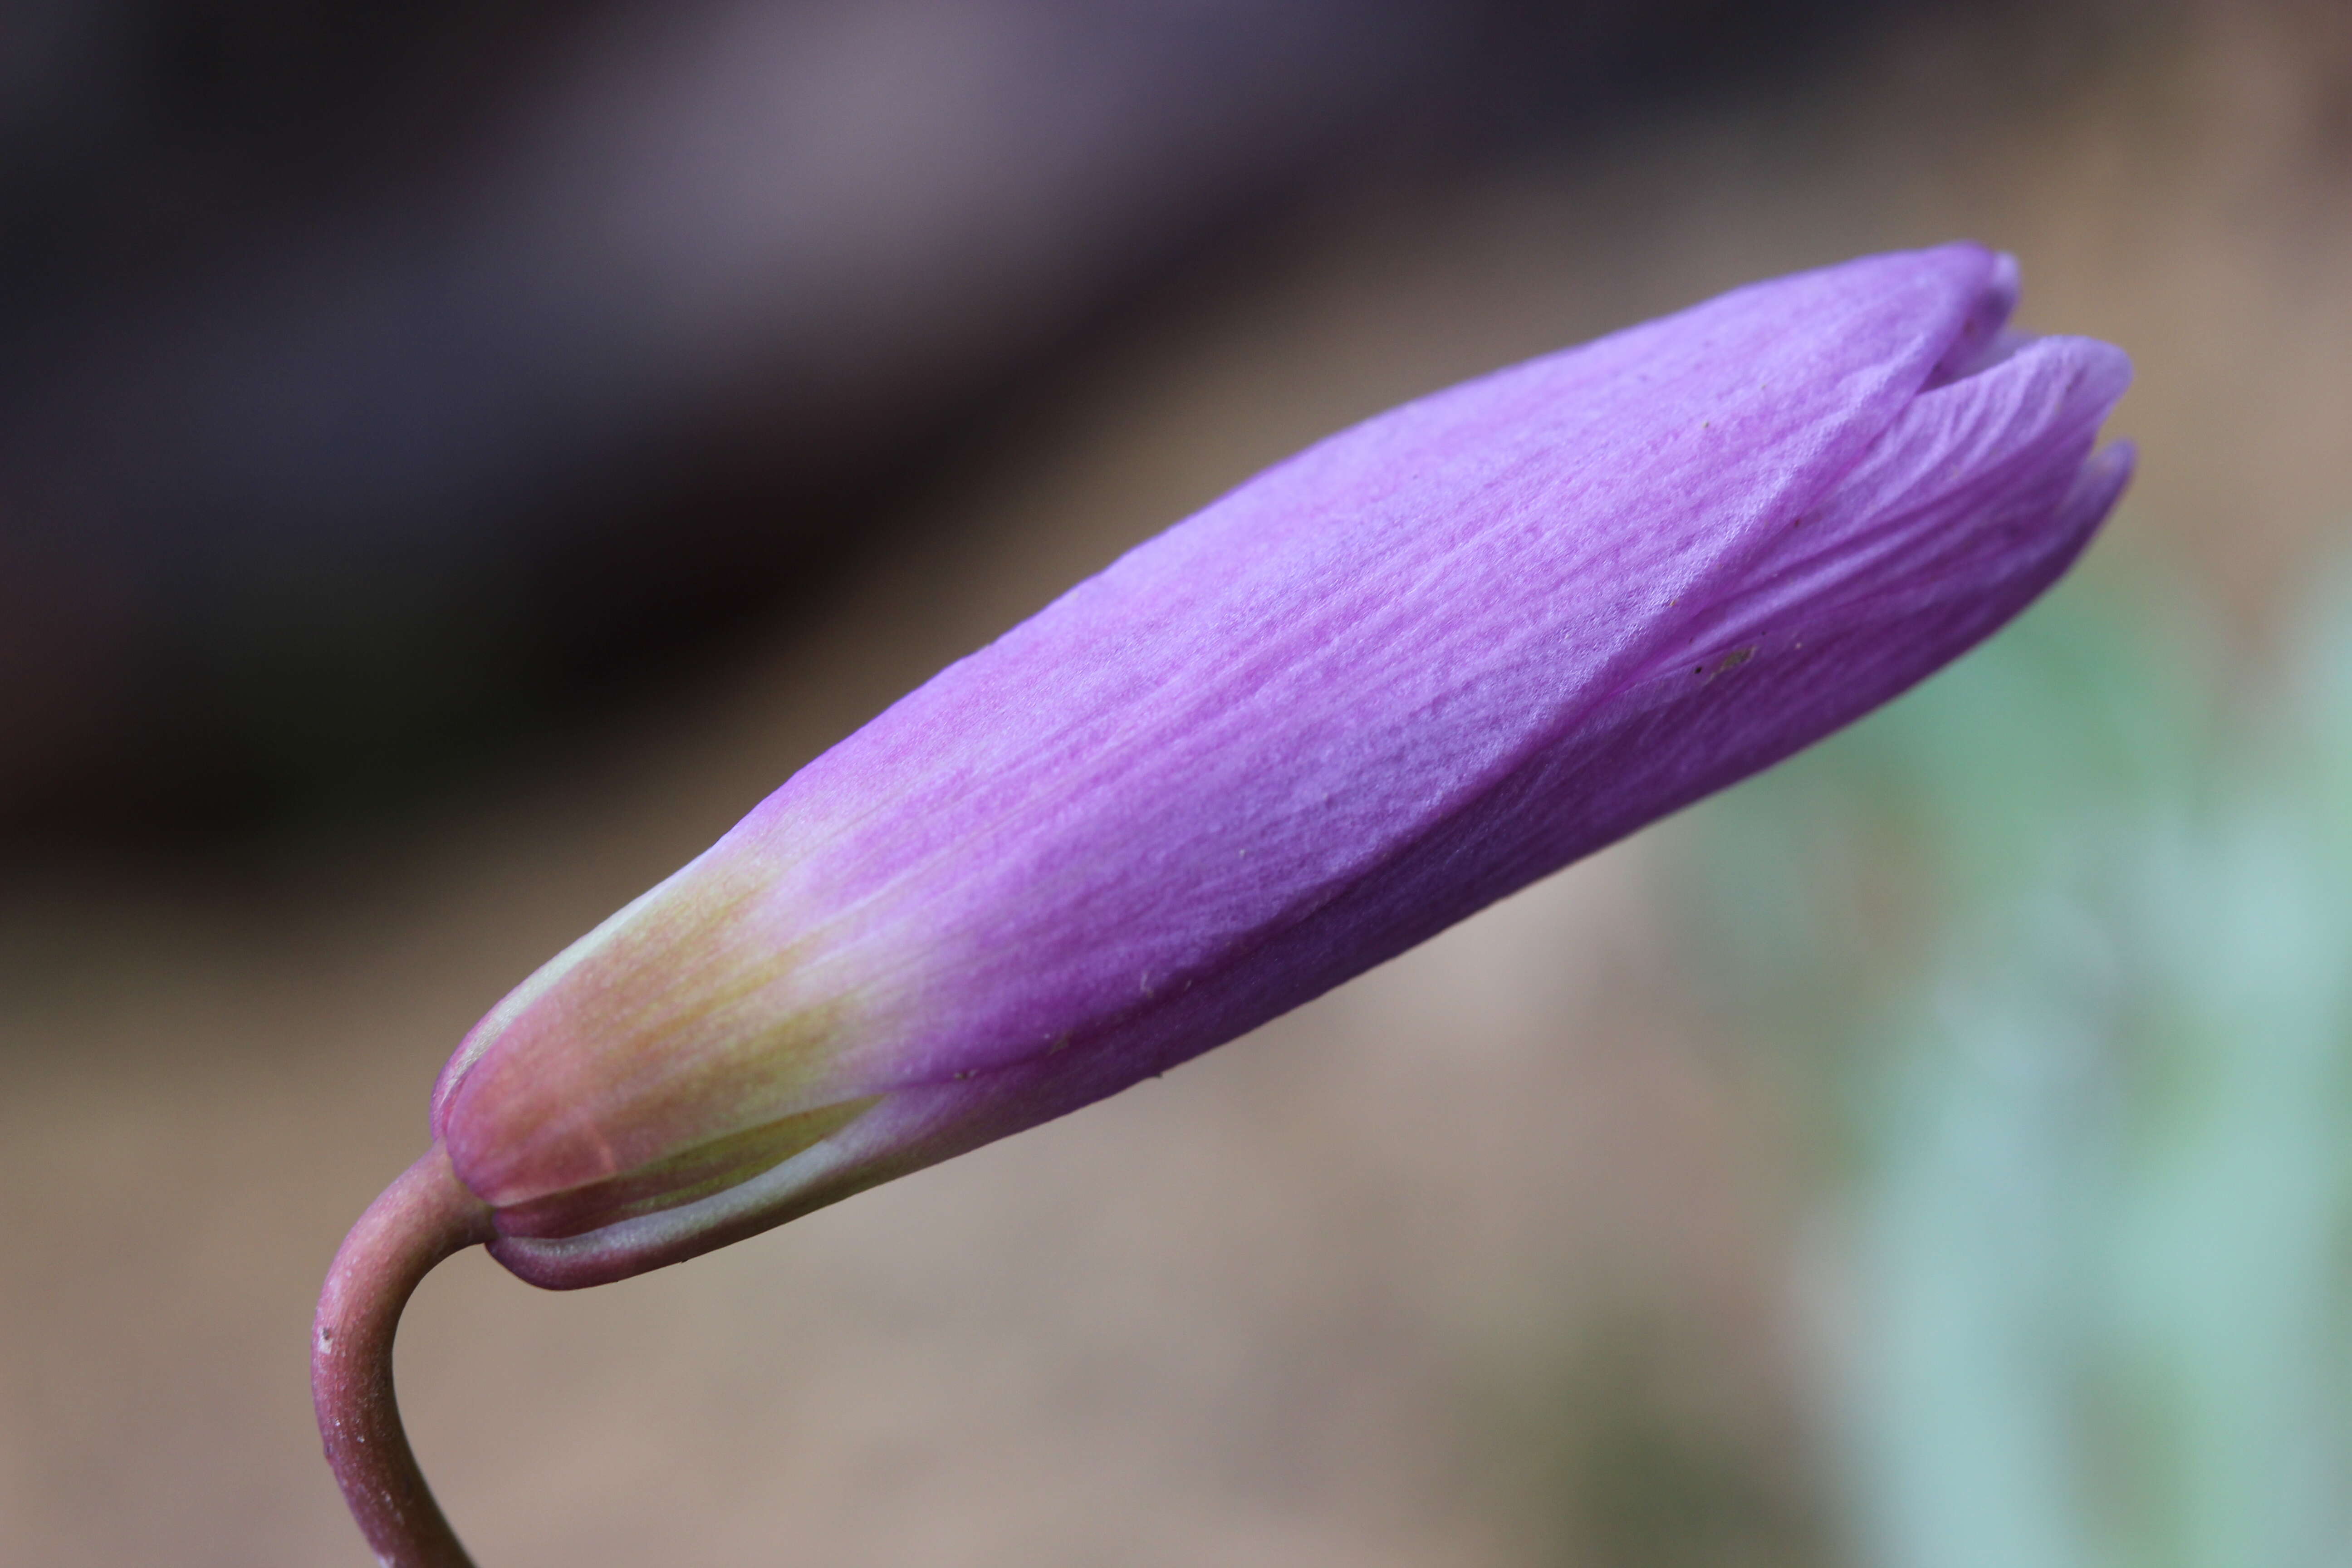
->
[310,1142,491,1568]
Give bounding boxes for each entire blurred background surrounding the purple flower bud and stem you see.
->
[0,0,2352,1568]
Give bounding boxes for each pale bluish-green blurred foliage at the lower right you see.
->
[1684,569,2352,1568]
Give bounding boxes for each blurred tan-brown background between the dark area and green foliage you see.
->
[0,0,2352,1568]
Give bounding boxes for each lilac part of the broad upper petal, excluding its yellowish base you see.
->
[762,247,1994,1088]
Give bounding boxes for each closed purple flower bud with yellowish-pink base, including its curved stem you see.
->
[320,245,2131,1561]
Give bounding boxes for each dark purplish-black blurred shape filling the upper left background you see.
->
[0,0,1994,853]
